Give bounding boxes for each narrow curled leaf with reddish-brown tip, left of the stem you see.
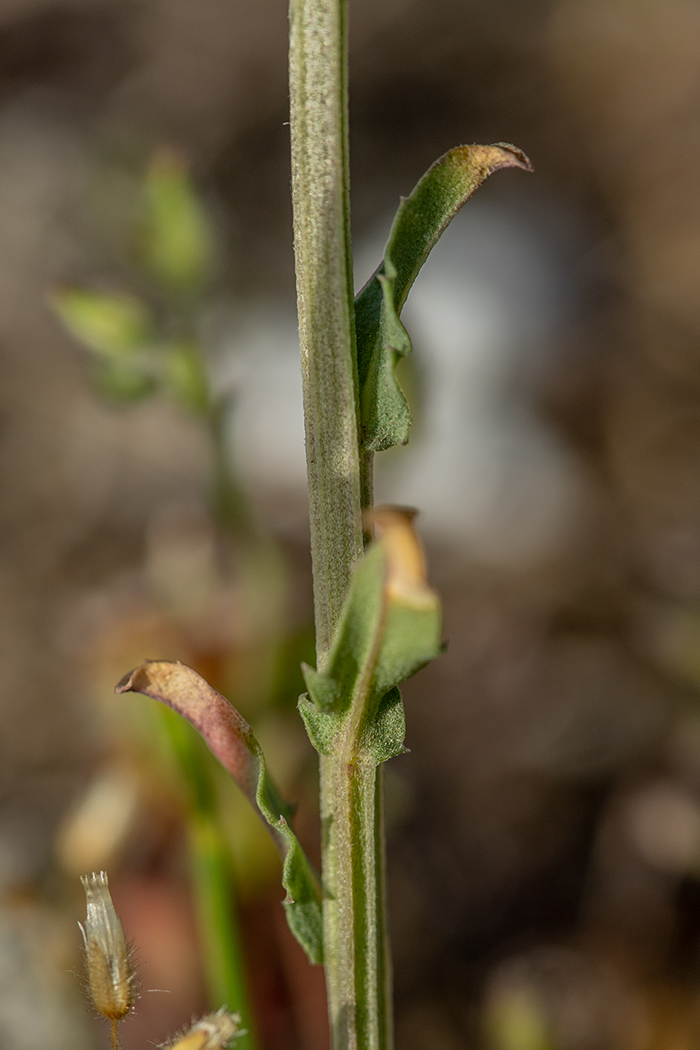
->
[114,660,323,963]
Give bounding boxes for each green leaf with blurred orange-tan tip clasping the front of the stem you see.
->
[299,508,442,764]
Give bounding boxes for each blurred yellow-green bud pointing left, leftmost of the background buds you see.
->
[51,288,153,360]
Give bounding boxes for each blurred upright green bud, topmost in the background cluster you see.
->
[141,148,213,294]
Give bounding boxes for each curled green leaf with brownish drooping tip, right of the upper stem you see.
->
[355,143,532,453]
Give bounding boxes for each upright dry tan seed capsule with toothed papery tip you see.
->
[79,872,136,1029]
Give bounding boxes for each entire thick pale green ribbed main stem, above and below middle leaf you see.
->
[290,0,393,1050]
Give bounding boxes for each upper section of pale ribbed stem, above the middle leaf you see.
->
[290,0,362,670]
